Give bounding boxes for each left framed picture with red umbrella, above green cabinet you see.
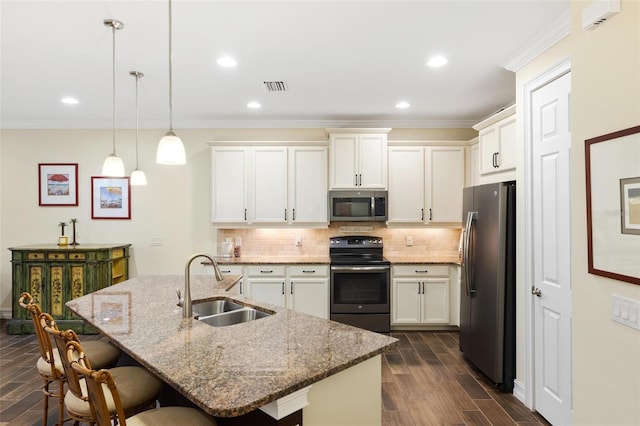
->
[38,163,78,206]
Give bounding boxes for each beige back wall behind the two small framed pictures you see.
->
[0,125,470,317]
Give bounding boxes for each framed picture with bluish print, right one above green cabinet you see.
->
[91,176,131,219]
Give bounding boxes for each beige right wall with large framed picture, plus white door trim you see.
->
[516,0,640,425]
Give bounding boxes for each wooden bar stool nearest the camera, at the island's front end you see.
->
[67,341,217,426]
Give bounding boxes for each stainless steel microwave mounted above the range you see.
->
[329,190,387,222]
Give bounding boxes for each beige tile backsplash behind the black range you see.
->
[217,223,461,256]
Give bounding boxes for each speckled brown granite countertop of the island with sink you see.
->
[66,274,397,417]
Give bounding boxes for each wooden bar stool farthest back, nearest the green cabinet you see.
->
[18,293,121,426]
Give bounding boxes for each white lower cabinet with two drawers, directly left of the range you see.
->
[245,265,329,318]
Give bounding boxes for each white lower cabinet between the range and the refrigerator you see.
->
[391,264,451,325]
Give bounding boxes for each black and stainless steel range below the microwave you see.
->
[329,236,391,333]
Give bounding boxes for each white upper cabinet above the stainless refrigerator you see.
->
[473,106,516,183]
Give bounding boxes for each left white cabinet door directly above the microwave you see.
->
[330,135,358,189]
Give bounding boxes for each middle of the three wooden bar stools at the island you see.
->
[40,313,164,424]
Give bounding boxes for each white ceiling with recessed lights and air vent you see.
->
[0,0,569,129]
